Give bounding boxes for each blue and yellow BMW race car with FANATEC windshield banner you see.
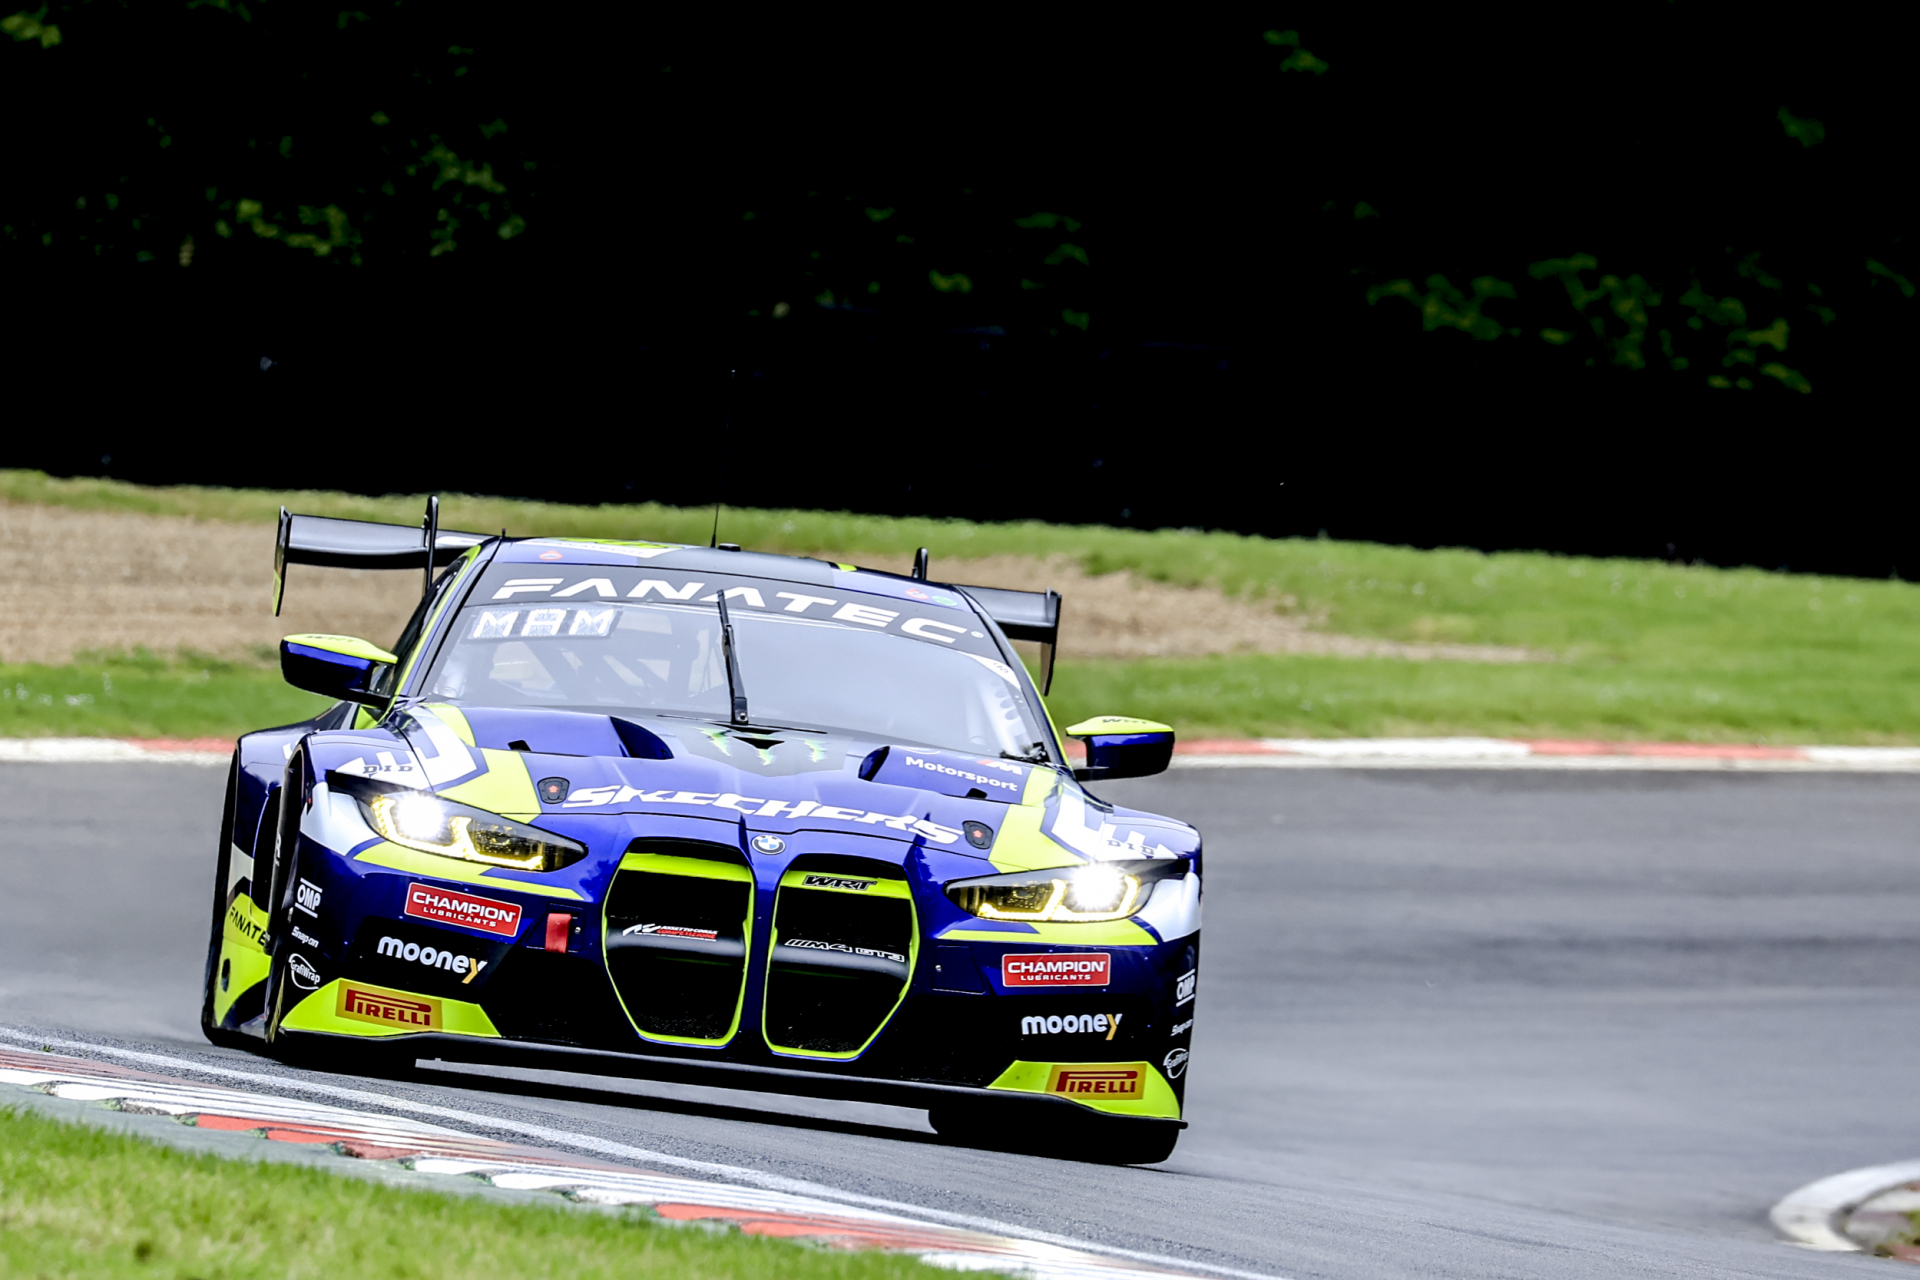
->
[202,503,1200,1163]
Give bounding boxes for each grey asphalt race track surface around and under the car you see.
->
[0,764,1920,1280]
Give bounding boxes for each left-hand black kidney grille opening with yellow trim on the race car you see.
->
[607,841,753,1044]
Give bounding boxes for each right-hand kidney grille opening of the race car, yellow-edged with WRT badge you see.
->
[764,860,918,1057]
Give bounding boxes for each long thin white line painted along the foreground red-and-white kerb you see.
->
[0,1027,1286,1280]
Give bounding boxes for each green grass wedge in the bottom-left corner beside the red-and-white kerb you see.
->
[0,1109,950,1280]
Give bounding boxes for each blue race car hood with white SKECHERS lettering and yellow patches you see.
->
[307,702,1198,869]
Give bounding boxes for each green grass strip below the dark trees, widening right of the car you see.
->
[11,472,1920,743]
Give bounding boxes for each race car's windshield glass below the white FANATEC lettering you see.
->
[426,574,1044,756]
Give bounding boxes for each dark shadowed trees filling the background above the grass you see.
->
[0,0,1920,576]
